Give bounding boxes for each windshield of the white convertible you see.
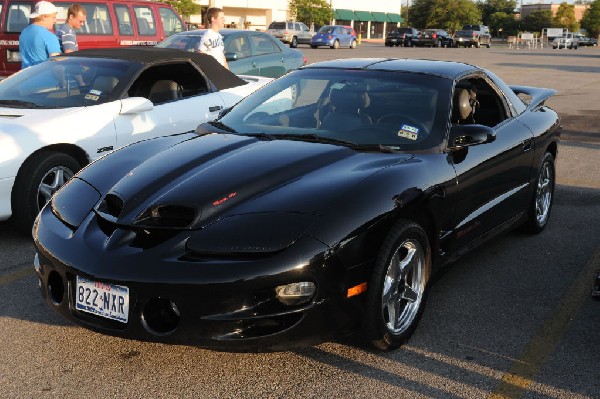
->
[0,57,140,108]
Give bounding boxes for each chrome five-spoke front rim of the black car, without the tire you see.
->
[381,239,426,335]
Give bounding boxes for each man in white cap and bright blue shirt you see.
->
[19,1,60,68]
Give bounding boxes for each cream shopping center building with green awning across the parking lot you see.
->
[186,0,406,39]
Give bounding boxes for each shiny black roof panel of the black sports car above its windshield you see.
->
[302,58,482,79]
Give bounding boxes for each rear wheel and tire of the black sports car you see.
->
[523,152,556,234]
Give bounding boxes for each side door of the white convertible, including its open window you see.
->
[115,61,225,147]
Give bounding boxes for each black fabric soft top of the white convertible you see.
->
[63,46,246,90]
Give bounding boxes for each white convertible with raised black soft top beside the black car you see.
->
[0,48,271,232]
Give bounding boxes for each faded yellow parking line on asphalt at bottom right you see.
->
[489,247,600,399]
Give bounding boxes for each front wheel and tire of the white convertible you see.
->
[12,151,81,235]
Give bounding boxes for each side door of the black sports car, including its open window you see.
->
[452,77,534,250]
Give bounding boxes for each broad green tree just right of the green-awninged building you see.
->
[408,0,481,32]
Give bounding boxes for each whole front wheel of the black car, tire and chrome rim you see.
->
[363,220,431,350]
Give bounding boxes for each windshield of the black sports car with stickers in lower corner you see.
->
[218,68,452,150]
